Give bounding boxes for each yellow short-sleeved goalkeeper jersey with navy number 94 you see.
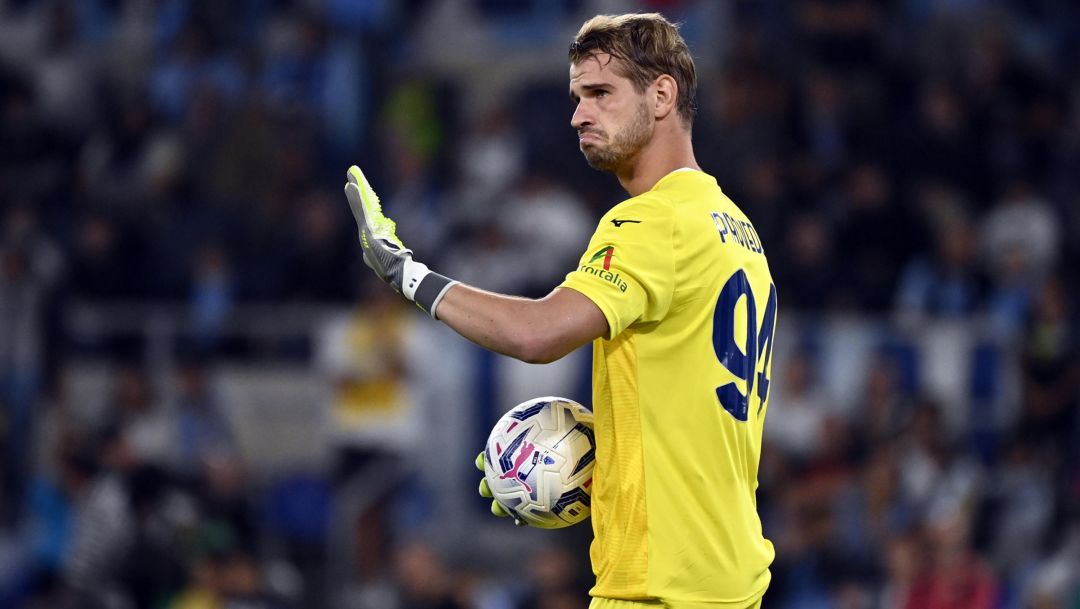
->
[561,170,777,608]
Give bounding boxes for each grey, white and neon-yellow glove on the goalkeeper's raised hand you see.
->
[345,165,458,320]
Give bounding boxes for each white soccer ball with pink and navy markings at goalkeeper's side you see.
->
[484,397,596,529]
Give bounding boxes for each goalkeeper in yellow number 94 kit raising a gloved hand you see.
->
[346,13,777,609]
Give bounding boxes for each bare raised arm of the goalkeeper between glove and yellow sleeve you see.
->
[437,284,607,364]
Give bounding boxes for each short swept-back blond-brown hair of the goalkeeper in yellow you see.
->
[569,13,698,126]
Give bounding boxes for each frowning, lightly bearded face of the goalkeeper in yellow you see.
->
[570,53,653,172]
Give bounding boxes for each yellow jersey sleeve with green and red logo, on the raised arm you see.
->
[559,195,675,338]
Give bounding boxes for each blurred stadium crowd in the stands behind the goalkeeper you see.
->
[0,0,1080,609]
